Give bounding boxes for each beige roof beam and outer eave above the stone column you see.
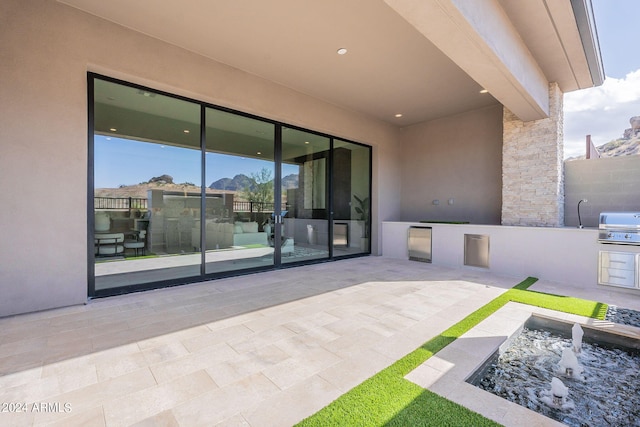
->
[385,0,604,121]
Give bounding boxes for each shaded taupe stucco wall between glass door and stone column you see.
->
[400,105,502,224]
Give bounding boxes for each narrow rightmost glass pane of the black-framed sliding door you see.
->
[333,140,371,257]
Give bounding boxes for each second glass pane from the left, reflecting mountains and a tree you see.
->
[202,109,275,274]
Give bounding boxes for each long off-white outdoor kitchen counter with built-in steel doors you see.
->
[382,221,640,286]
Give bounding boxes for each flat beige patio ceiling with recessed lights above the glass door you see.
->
[59,0,600,126]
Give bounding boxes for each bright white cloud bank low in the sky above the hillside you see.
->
[564,69,640,158]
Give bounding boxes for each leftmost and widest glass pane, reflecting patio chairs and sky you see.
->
[90,79,201,291]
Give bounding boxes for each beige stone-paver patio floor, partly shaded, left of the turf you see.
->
[0,257,632,426]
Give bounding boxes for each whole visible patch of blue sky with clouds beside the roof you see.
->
[564,0,640,158]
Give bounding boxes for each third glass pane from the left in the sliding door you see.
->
[280,127,331,264]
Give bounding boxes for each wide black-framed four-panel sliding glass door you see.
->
[87,74,371,296]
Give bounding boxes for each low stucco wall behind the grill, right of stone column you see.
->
[564,156,640,227]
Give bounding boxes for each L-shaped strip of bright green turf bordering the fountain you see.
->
[298,277,607,427]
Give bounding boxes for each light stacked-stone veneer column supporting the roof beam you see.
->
[502,83,564,227]
